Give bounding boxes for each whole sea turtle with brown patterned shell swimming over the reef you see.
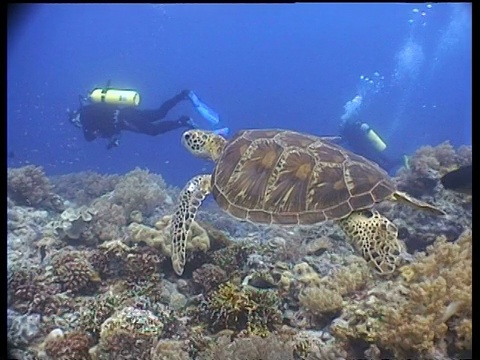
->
[170,129,443,275]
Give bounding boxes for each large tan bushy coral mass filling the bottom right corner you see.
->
[333,231,472,358]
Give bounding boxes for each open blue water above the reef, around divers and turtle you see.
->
[7,3,472,186]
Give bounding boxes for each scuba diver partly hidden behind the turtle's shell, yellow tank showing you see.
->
[340,121,405,173]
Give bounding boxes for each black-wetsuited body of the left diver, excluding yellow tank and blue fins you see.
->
[67,90,194,149]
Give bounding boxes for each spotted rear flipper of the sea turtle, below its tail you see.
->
[338,210,404,275]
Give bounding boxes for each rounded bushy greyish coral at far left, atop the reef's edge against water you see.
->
[7,165,52,206]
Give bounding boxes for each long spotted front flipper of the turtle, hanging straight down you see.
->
[170,175,211,275]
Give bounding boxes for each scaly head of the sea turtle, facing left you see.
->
[182,129,227,161]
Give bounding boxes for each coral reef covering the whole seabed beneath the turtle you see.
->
[7,155,473,360]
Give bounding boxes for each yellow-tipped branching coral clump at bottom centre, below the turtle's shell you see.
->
[200,282,281,336]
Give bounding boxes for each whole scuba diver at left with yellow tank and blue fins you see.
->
[67,81,228,149]
